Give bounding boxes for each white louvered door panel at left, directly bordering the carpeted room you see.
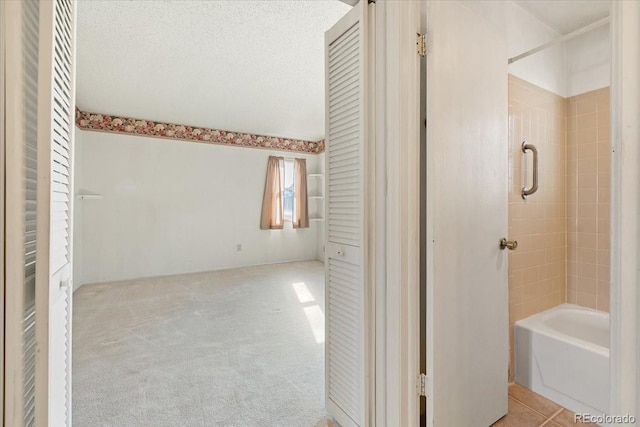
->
[36,0,75,427]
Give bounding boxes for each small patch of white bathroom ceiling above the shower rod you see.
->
[514,0,611,35]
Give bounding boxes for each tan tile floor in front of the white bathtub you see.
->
[493,383,595,427]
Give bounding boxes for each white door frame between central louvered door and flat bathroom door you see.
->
[372,0,421,427]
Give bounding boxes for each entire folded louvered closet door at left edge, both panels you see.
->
[0,0,75,427]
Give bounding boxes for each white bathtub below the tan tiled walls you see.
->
[515,304,609,415]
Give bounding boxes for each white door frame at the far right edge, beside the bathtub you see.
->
[610,1,640,416]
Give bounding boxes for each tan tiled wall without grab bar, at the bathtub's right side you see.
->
[567,88,611,311]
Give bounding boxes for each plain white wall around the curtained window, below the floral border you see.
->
[74,130,320,286]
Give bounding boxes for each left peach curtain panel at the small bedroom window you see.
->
[260,156,284,230]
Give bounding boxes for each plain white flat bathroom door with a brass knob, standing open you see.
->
[426,1,508,427]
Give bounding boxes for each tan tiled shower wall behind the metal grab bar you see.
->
[509,76,567,376]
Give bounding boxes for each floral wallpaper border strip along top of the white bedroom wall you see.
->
[76,108,325,154]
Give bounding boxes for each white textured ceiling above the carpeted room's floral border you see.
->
[76,0,350,140]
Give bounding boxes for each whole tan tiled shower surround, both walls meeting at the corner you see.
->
[509,75,609,380]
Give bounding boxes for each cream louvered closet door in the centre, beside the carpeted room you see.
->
[325,1,369,427]
